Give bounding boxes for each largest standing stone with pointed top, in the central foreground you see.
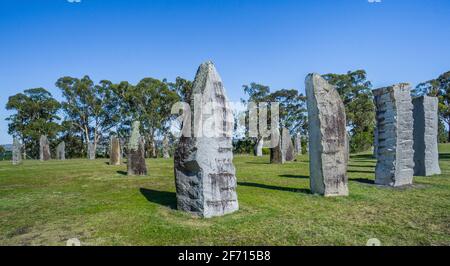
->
[174,62,239,218]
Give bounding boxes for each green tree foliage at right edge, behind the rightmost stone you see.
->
[413,71,450,142]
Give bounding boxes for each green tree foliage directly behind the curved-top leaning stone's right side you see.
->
[323,70,375,152]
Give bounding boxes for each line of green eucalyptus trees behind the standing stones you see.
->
[6,70,450,158]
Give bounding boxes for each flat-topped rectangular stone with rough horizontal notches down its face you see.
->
[373,83,414,187]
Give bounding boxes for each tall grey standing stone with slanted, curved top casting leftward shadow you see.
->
[305,74,348,196]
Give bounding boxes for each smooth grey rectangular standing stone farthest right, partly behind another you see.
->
[413,96,441,176]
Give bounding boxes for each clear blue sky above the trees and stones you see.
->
[0,0,450,144]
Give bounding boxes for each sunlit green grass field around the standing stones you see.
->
[0,145,450,245]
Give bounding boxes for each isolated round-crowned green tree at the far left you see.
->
[6,88,61,158]
